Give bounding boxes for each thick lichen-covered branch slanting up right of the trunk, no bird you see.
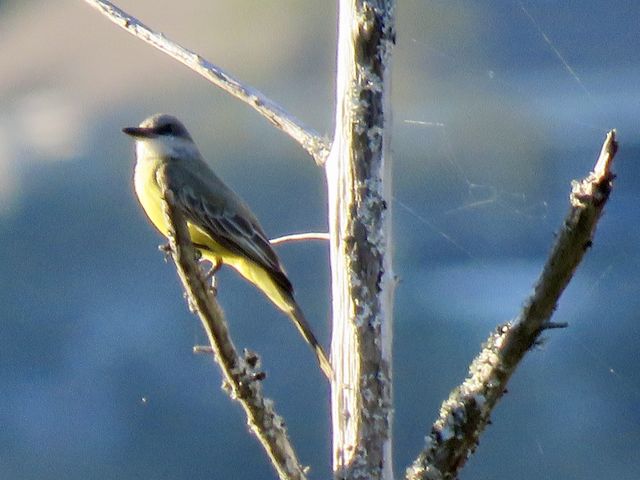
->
[405,130,617,480]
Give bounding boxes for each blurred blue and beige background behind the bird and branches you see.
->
[0,0,640,480]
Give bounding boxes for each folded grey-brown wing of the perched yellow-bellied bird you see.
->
[160,160,293,294]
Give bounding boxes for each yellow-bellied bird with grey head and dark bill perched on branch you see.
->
[122,113,333,380]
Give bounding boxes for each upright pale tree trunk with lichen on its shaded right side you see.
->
[325,0,395,480]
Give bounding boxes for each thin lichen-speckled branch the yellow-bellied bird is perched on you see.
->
[158,170,306,480]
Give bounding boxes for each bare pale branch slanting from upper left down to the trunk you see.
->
[85,0,331,165]
